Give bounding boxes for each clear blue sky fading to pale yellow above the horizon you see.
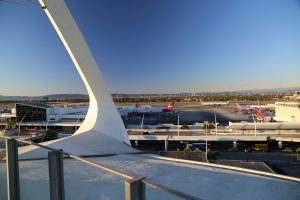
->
[0,0,300,95]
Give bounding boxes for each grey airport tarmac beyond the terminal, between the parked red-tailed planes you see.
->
[124,105,253,125]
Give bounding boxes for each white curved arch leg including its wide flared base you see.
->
[20,0,137,158]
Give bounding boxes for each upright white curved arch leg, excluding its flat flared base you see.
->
[40,0,130,145]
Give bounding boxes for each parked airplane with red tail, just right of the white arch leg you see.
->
[118,101,175,116]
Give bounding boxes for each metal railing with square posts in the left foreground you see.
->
[0,136,199,200]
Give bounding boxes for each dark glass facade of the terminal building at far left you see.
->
[16,104,47,122]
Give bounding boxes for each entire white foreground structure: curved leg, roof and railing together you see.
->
[0,0,300,200]
